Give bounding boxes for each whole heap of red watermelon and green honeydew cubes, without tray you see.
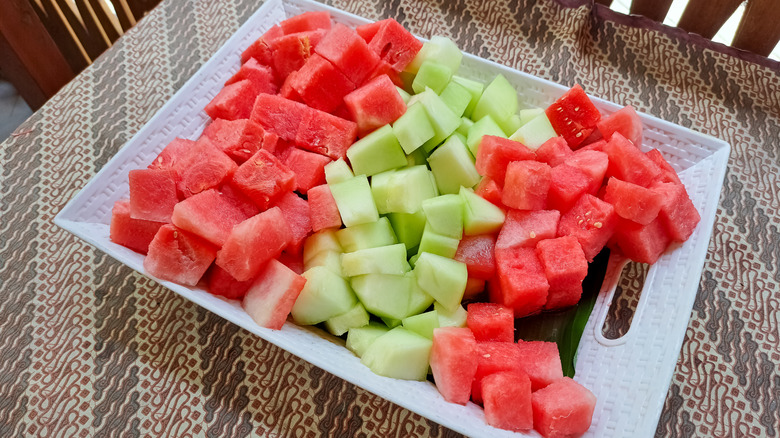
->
[110,12,699,436]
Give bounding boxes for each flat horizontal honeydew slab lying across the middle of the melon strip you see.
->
[341,243,411,277]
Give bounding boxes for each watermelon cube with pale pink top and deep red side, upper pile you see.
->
[315,24,379,85]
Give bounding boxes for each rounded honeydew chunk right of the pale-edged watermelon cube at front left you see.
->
[290,266,357,325]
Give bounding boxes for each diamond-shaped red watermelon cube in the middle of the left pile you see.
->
[232,149,296,210]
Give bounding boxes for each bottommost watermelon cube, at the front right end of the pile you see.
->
[531,377,596,438]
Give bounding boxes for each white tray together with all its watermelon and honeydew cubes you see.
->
[55,0,730,437]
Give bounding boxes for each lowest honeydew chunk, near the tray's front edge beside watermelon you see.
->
[360,327,433,380]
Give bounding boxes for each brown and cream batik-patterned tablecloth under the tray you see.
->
[0,0,780,438]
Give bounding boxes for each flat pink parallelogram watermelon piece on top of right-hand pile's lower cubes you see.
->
[496,210,561,249]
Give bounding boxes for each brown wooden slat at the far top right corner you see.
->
[731,0,780,56]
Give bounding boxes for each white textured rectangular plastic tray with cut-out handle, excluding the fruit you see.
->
[55,0,730,437]
